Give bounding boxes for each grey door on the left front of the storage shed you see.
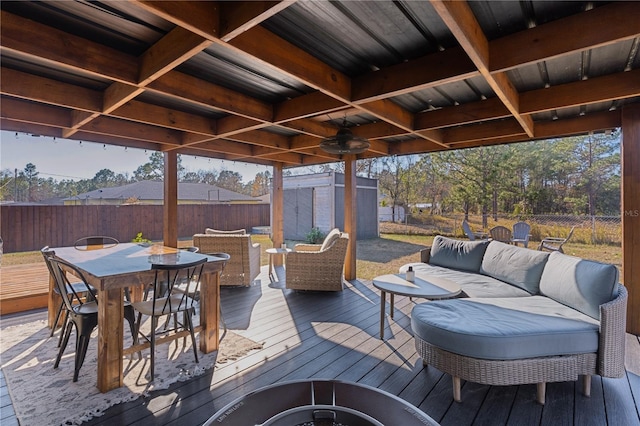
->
[284,188,313,241]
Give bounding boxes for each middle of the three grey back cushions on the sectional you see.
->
[480,241,549,294]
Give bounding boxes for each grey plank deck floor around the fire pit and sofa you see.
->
[2,266,640,426]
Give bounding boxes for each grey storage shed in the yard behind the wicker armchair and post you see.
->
[283,172,379,241]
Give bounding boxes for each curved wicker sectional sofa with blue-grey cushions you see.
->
[400,236,627,404]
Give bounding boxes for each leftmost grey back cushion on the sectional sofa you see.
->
[429,235,489,272]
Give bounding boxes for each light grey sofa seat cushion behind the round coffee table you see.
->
[400,263,531,297]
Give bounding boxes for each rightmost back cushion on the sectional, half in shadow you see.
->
[540,252,618,319]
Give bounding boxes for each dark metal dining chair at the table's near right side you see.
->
[133,257,207,381]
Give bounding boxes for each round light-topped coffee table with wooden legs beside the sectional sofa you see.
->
[373,272,462,340]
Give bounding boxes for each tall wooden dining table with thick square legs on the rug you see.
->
[48,243,228,392]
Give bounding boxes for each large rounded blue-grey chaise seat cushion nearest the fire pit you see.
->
[411,296,599,360]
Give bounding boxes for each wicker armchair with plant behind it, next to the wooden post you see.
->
[286,229,349,291]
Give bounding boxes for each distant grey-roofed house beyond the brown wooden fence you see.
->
[64,180,260,206]
